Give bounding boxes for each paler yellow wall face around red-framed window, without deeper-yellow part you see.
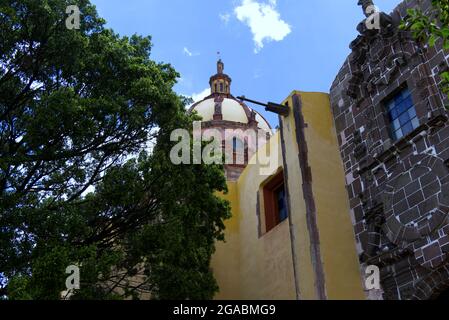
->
[238,132,295,300]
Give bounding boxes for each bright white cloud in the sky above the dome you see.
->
[234,0,291,53]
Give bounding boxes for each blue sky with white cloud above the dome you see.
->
[91,0,401,127]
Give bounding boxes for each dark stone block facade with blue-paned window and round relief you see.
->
[330,0,449,300]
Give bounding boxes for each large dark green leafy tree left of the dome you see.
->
[0,0,230,299]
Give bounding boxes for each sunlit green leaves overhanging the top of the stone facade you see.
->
[401,0,449,97]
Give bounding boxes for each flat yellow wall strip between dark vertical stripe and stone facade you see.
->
[288,91,365,299]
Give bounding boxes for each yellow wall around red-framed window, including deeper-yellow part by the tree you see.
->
[211,132,295,300]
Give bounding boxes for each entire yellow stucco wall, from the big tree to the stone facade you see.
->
[211,91,364,299]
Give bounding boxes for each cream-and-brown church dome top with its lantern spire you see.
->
[190,60,272,135]
